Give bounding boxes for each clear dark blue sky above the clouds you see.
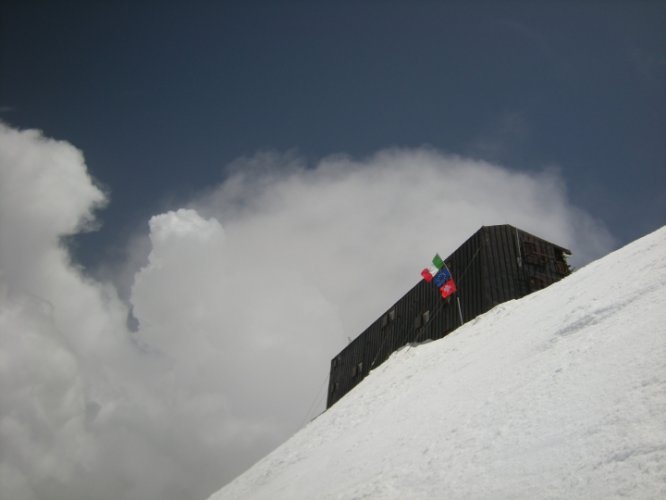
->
[0,1,666,270]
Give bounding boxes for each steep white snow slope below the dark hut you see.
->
[210,226,666,500]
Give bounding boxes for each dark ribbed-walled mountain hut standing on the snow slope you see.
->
[326,224,571,408]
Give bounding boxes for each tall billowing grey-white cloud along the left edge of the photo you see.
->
[0,125,236,500]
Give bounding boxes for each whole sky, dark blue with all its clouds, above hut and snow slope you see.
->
[0,1,666,499]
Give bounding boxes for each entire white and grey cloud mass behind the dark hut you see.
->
[0,124,612,500]
